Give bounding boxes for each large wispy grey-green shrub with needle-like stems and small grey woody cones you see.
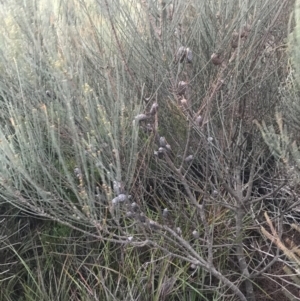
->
[0,0,288,300]
